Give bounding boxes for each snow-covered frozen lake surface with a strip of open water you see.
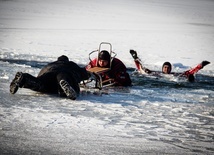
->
[0,0,214,155]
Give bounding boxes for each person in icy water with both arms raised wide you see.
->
[130,50,210,82]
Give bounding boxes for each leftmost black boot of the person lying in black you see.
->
[10,72,24,94]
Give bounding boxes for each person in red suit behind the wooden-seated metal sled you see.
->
[86,50,132,86]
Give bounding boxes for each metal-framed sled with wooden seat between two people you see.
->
[82,42,116,89]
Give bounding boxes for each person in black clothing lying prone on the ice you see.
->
[10,55,89,100]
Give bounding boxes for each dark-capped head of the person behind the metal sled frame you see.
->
[98,50,111,67]
